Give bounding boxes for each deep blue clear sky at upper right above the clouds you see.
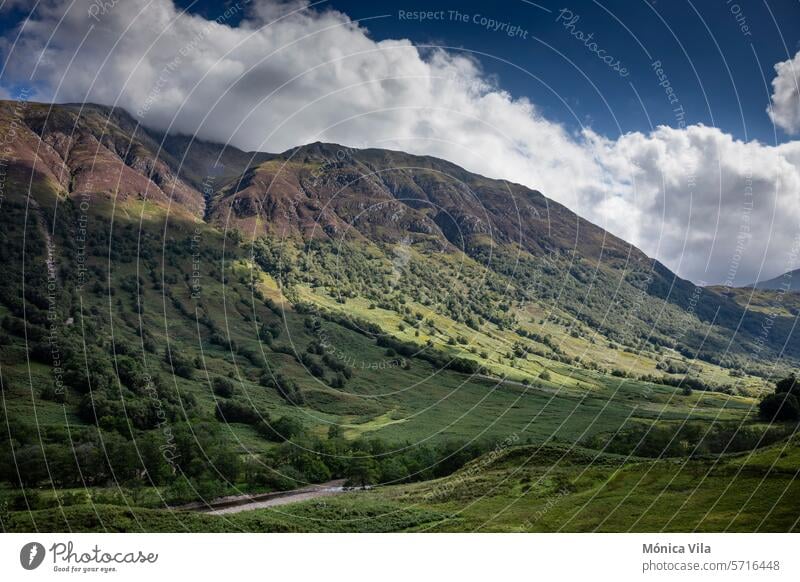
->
[179,0,800,143]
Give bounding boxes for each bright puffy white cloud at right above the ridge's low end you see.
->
[586,125,800,284]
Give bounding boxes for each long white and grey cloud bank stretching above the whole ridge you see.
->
[0,0,800,284]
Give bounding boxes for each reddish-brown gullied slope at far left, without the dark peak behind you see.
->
[0,102,204,216]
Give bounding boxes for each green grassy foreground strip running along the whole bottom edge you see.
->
[5,441,800,532]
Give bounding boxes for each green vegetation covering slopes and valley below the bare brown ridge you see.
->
[0,101,798,531]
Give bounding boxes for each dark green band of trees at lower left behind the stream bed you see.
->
[0,399,500,503]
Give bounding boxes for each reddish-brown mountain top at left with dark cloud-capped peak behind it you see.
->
[0,101,270,216]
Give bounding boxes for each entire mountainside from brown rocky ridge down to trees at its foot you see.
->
[0,102,800,529]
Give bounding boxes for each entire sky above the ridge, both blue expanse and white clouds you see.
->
[0,0,800,285]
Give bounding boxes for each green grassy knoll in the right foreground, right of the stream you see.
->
[342,443,800,532]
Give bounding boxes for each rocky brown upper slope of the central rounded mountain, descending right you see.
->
[208,143,800,367]
